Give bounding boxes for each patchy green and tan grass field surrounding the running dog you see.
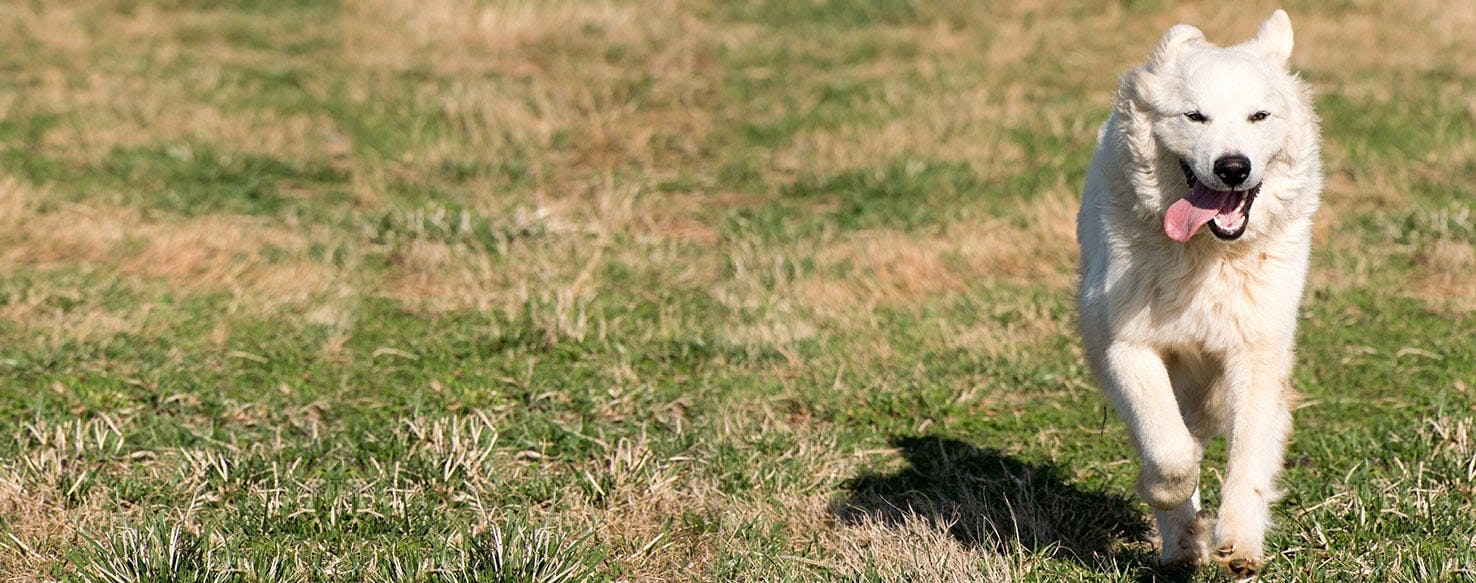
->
[0,0,1476,582]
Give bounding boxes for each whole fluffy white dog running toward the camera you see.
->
[1076,10,1322,579]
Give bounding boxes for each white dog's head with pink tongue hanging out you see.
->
[1119,10,1320,242]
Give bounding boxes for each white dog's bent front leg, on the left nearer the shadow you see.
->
[1089,344,1204,565]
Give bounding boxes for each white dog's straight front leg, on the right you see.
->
[1215,357,1292,579]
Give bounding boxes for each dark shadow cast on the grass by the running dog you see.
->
[831,437,1179,580]
